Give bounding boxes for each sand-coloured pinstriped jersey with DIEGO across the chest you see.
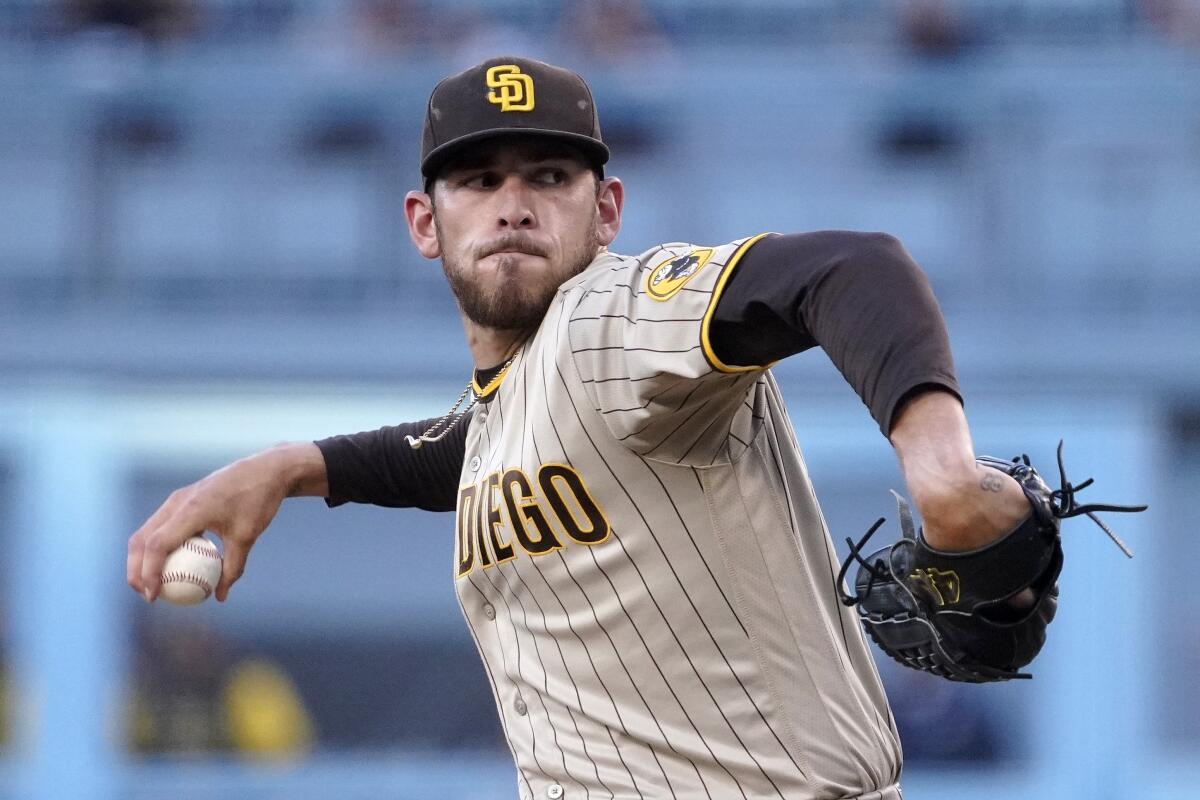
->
[455,237,900,800]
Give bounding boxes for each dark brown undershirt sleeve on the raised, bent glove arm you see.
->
[709,230,962,435]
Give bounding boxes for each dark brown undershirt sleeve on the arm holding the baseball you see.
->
[314,415,470,511]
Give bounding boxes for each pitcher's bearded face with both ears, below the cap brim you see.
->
[409,138,619,330]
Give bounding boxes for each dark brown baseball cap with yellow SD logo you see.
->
[421,56,608,181]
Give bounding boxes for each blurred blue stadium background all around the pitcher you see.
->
[0,0,1200,800]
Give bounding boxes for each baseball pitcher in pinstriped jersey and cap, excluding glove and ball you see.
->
[128,58,1030,800]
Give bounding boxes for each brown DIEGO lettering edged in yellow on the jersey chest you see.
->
[455,463,612,578]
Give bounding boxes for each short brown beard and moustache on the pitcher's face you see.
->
[438,221,600,330]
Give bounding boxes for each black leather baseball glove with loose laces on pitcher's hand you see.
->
[838,441,1147,684]
